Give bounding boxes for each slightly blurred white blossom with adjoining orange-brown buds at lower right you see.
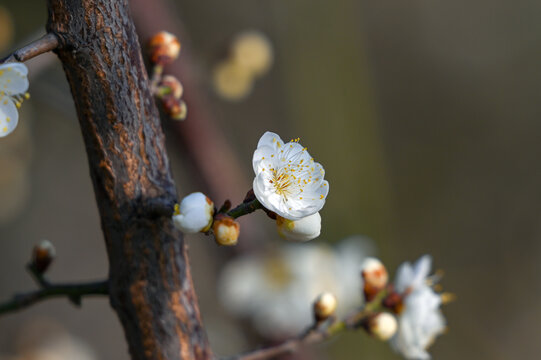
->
[362,255,446,359]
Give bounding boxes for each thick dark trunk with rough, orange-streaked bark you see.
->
[47,0,211,360]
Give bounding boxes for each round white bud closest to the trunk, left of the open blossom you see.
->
[173,192,214,234]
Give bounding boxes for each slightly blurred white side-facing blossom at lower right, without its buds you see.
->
[391,255,445,360]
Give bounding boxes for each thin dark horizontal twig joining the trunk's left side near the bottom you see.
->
[0,281,109,314]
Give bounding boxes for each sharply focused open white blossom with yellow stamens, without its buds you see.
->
[252,131,329,220]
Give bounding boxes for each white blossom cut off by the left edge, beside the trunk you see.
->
[0,63,28,137]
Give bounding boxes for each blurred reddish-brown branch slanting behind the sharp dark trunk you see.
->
[130,0,251,204]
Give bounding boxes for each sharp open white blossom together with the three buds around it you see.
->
[173,132,329,245]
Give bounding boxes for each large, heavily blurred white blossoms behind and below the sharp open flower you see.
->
[218,237,373,339]
